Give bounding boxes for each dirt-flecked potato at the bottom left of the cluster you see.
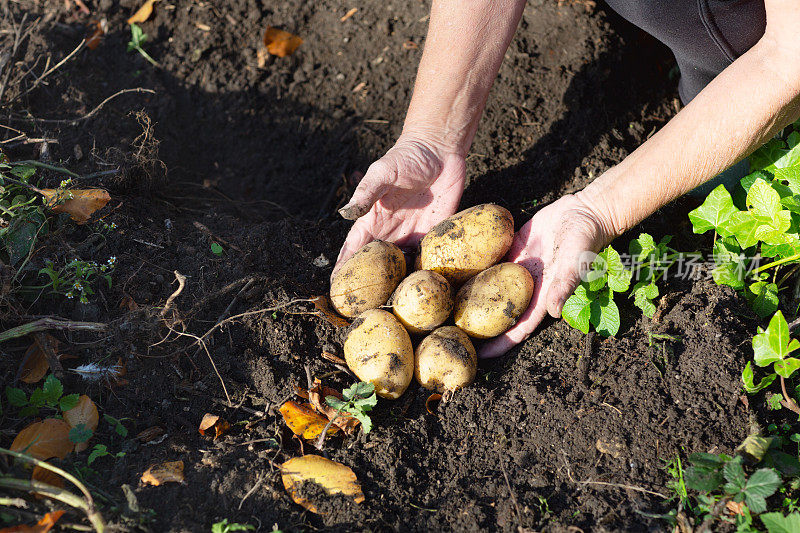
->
[344,309,414,400]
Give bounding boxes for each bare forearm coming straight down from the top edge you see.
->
[403,0,525,155]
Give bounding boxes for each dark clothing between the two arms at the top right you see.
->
[607,0,767,104]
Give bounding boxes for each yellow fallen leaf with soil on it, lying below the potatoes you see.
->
[280,455,364,514]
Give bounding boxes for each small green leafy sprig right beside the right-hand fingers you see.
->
[561,246,632,337]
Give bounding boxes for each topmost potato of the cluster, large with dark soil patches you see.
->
[420,204,514,286]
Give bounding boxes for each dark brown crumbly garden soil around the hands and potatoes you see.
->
[0,0,757,532]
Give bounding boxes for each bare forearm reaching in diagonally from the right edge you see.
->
[580,33,800,235]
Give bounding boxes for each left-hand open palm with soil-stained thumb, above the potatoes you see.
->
[333,134,466,273]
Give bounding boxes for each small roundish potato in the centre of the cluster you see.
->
[392,270,453,333]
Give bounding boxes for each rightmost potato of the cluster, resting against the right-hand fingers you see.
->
[454,263,533,339]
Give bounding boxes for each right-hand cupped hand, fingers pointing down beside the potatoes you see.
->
[478,193,613,358]
